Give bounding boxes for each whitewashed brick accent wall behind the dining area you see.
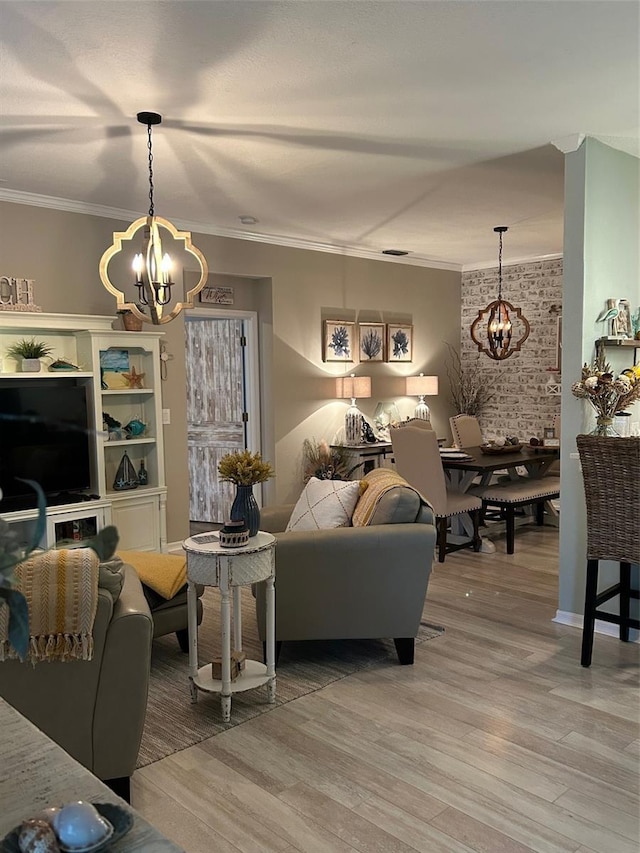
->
[460,259,562,442]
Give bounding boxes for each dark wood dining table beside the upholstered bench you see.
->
[440,444,560,554]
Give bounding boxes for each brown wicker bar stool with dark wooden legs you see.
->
[576,435,640,666]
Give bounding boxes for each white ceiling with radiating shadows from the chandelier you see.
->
[0,0,640,269]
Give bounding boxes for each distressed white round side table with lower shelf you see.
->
[182,531,276,722]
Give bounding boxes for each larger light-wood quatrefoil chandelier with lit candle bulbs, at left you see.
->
[100,112,209,326]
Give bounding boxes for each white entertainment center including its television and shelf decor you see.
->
[0,311,167,551]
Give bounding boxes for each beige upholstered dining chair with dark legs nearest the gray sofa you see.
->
[389,426,482,563]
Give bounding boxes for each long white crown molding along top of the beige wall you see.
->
[0,187,462,272]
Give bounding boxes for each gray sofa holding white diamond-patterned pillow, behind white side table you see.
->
[255,478,436,664]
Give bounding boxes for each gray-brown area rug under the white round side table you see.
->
[138,589,444,767]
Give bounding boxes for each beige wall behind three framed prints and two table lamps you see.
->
[0,203,460,541]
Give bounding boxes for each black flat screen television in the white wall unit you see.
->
[0,378,91,513]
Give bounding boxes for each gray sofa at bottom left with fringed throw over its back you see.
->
[0,564,153,800]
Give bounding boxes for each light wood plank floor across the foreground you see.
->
[132,527,640,853]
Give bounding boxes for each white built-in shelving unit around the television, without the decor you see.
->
[0,311,167,551]
